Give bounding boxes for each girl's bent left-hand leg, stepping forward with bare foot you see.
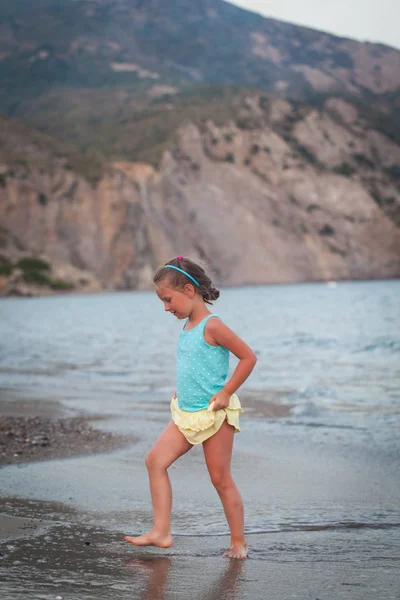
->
[125,421,193,548]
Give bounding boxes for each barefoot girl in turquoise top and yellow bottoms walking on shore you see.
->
[125,256,257,558]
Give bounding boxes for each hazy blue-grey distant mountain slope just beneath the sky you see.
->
[0,0,400,105]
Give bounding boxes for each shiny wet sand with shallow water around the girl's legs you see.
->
[0,398,400,600]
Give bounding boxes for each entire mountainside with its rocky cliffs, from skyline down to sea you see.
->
[0,0,400,293]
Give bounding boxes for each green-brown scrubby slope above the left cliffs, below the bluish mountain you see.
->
[0,86,258,183]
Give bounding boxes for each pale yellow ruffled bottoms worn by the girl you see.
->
[170,394,243,445]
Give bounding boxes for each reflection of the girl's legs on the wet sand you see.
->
[126,556,245,600]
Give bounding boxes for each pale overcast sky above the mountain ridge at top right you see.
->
[228,0,400,48]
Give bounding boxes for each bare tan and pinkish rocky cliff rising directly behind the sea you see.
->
[0,92,400,289]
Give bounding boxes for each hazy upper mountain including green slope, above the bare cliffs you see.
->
[0,0,400,173]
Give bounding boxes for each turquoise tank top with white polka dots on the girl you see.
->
[176,314,229,412]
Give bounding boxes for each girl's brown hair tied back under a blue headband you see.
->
[153,256,219,304]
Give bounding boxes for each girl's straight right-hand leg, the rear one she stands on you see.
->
[203,421,248,558]
